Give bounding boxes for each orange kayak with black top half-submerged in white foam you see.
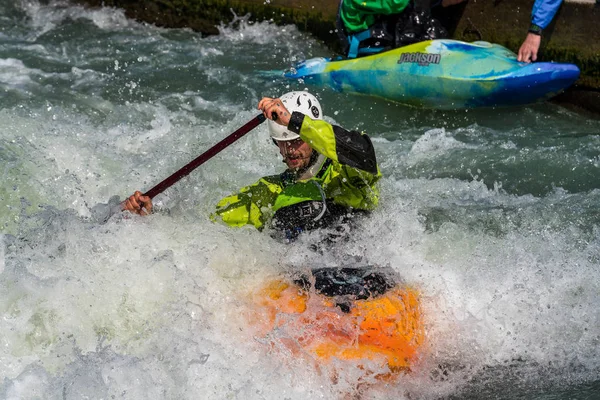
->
[246,268,424,378]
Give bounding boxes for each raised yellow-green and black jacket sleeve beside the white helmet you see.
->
[287,111,378,175]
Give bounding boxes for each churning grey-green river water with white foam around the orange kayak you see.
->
[0,0,600,399]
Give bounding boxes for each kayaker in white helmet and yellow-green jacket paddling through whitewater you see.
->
[124,91,381,241]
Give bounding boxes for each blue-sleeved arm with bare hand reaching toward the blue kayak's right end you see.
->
[517,0,563,62]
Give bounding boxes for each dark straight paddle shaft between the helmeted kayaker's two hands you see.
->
[145,114,266,198]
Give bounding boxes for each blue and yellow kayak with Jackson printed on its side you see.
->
[285,39,580,109]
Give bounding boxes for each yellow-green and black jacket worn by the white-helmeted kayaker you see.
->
[213,112,381,229]
